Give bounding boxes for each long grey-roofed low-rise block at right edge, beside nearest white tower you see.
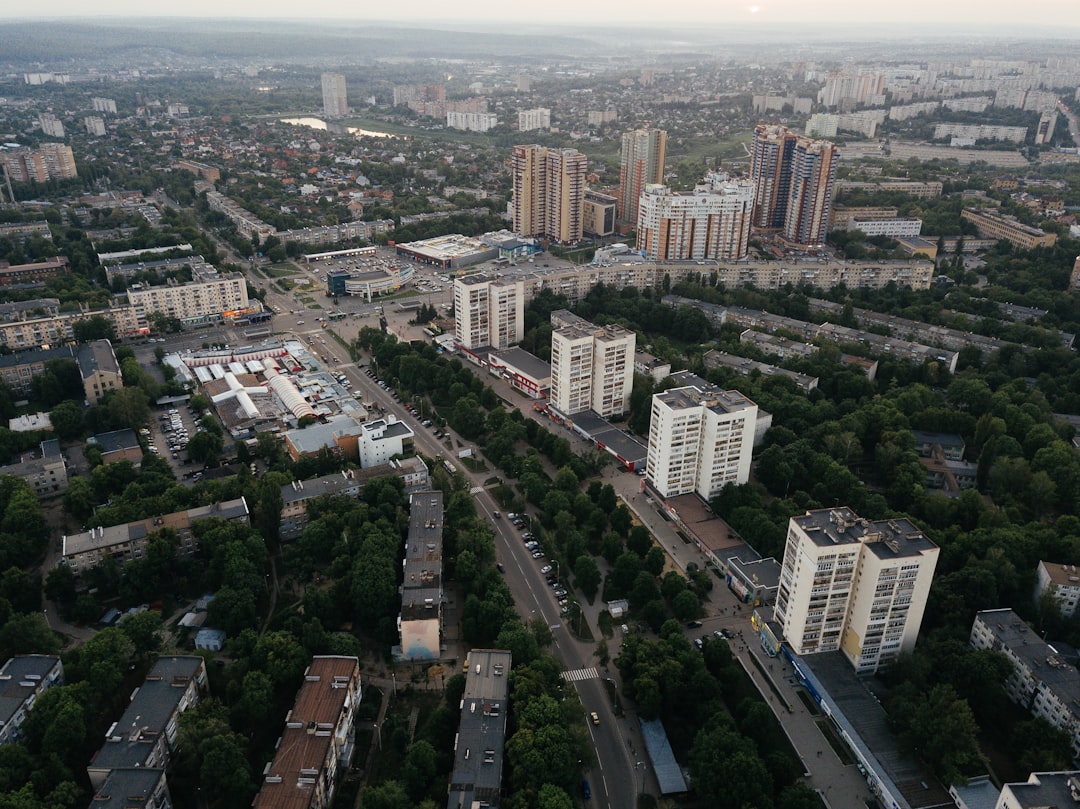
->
[970,609,1080,755]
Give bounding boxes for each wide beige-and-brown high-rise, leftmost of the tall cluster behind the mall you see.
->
[512,145,589,244]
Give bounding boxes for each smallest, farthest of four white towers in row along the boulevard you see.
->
[454,273,525,349]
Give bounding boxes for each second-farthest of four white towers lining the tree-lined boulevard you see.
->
[551,309,637,418]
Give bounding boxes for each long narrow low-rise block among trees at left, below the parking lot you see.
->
[62,497,249,575]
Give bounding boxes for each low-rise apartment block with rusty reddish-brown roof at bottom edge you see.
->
[252,656,362,809]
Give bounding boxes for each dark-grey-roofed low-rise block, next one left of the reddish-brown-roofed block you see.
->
[86,656,208,790]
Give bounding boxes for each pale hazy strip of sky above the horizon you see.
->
[0,0,1080,33]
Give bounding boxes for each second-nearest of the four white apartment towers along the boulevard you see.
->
[643,384,757,500]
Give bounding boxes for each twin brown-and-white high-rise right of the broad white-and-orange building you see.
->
[751,124,840,245]
